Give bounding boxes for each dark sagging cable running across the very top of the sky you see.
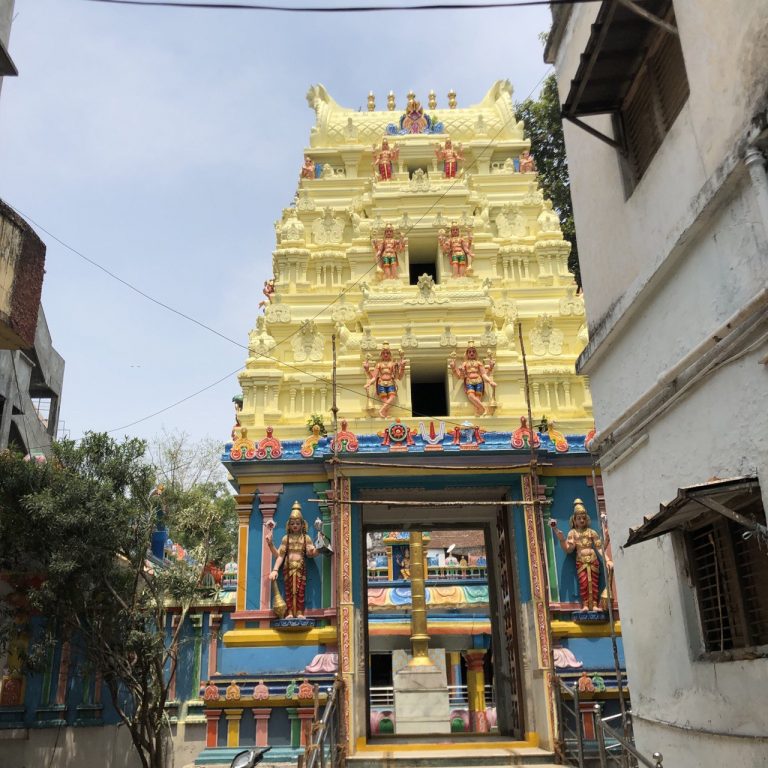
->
[86,0,602,13]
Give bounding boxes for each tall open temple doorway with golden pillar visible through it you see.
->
[363,492,525,740]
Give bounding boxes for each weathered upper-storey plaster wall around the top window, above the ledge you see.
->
[555,0,768,330]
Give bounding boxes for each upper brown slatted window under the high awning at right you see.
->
[621,8,689,181]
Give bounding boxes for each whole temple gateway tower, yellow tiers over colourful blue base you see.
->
[198,81,624,765]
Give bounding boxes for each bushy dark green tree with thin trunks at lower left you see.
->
[0,433,232,768]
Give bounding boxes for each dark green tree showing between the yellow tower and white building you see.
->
[515,75,581,289]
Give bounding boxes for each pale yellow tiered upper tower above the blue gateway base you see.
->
[239,80,592,440]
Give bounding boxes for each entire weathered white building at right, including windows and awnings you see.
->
[546,0,768,766]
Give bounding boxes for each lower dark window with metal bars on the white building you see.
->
[685,494,768,653]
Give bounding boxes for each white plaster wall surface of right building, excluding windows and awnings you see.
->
[554,0,768,768]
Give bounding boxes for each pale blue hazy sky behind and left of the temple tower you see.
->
[0,0,550,448]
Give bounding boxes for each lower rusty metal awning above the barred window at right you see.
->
[624,476,768,547]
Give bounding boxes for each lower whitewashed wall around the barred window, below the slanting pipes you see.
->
[604,353,768,767]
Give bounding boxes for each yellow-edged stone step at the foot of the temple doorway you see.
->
[347,744,555,768]
